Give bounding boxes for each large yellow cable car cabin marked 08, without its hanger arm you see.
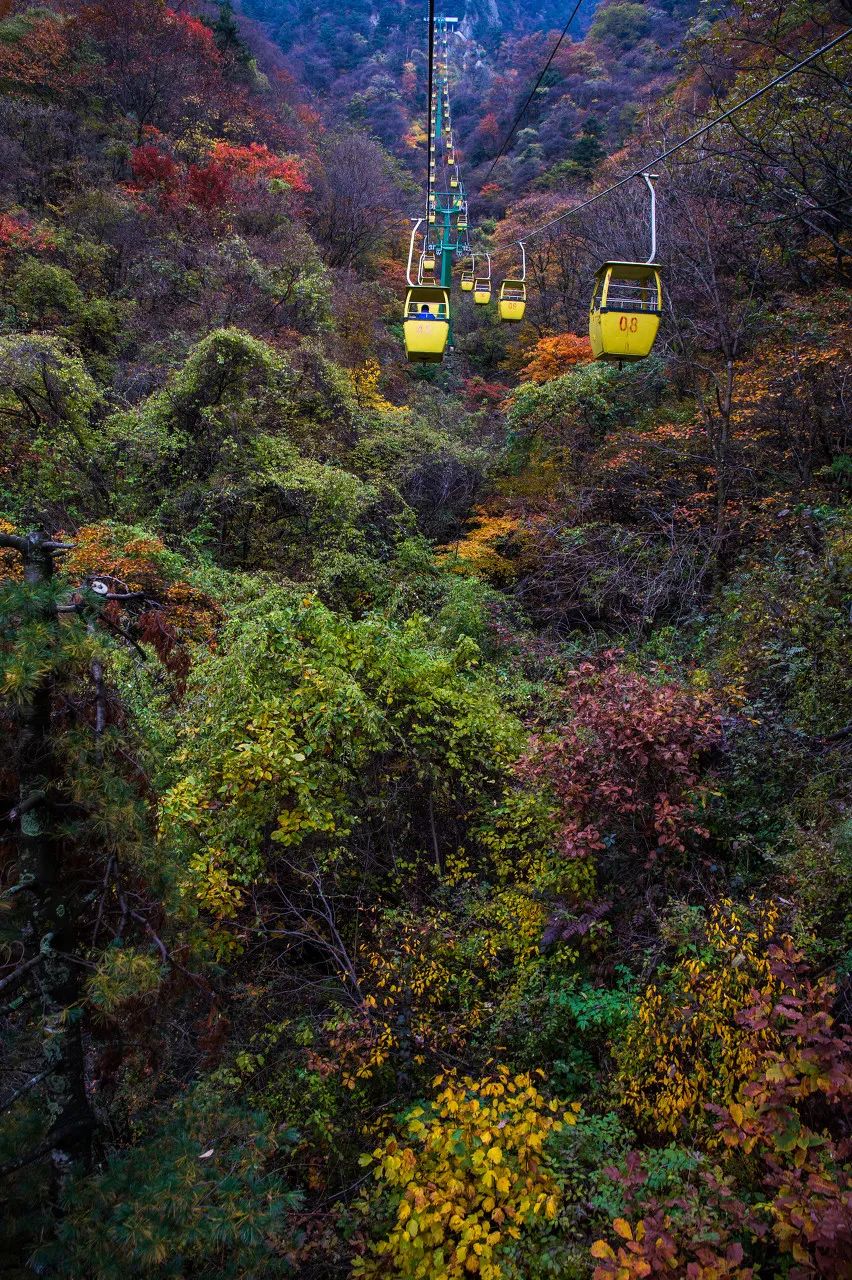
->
[588,262,663,361]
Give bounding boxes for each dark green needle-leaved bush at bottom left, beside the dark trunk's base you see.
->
[33,1092,299,1280]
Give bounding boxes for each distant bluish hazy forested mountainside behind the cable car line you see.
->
[236,0,700,199]
